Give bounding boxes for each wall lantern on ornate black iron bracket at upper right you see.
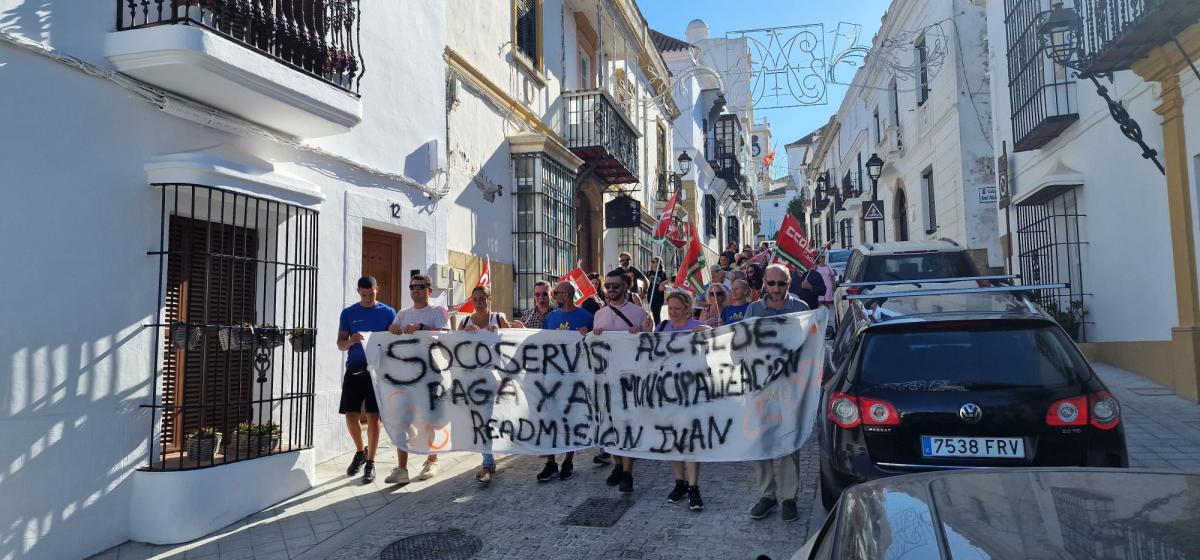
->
[1038,1,1166,175]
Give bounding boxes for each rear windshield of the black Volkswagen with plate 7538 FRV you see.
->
[858,321,1090,390]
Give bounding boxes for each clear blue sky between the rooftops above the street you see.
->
[637,0,890,177]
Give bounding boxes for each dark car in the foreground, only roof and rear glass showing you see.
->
[792,468,1200,560]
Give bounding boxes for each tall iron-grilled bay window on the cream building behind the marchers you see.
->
[512,152,576,311]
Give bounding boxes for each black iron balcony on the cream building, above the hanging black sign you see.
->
[563,90,641,185]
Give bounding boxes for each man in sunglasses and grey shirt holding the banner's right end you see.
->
[746,264,809,522]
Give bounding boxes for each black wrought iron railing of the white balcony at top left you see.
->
[116,0,365,92]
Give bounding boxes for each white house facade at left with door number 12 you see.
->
[0,0,450,559]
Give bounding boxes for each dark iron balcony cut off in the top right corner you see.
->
[1075,0,1200,73]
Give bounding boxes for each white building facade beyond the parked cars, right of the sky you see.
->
[808,0,1003,269]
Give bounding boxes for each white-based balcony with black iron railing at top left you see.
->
[104,0,364,139]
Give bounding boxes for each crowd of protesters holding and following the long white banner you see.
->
[337,243,836,522]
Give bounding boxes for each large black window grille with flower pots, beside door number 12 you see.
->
[143,183,319,470]
